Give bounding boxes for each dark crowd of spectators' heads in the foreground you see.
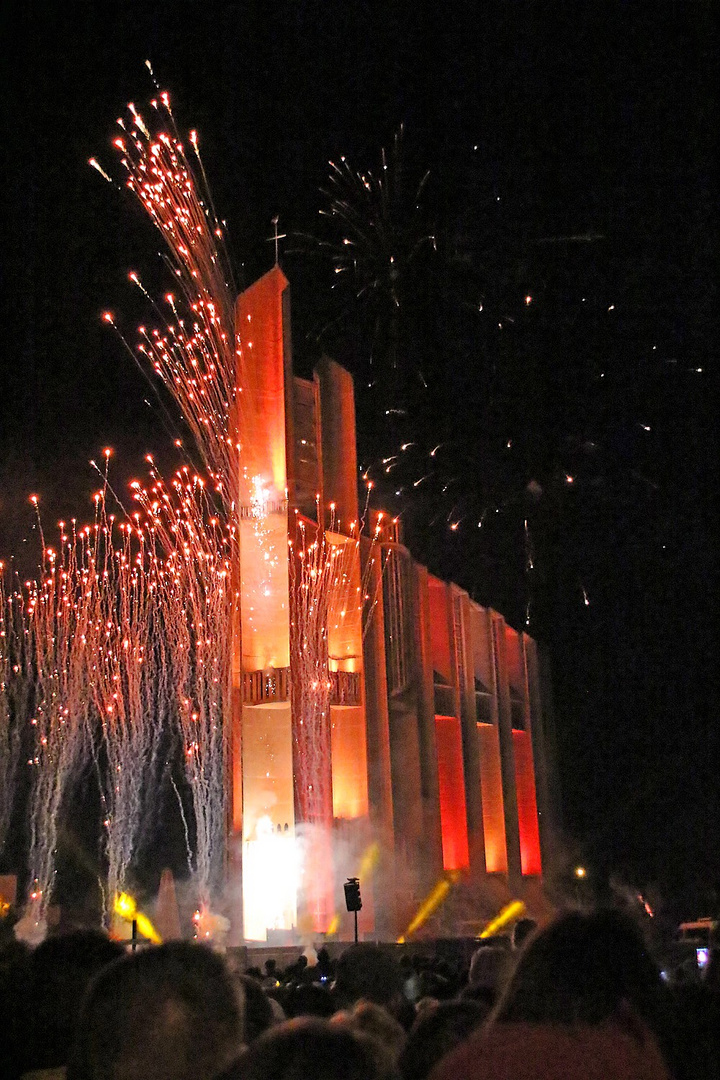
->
[0,912,720,1080]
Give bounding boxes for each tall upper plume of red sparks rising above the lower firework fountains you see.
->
[97,92,239,496]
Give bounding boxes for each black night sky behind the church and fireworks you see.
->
[0,0,720,915]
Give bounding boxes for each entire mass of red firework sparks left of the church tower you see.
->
[0,88,242,934]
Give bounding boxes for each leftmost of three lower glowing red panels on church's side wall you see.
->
[435,716,470,870]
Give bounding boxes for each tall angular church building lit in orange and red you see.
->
[229,267,556,943]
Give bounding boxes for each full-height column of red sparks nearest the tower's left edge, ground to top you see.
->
[92,93,243,909]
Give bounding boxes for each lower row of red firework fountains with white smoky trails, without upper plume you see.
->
[0,465,233,934]
